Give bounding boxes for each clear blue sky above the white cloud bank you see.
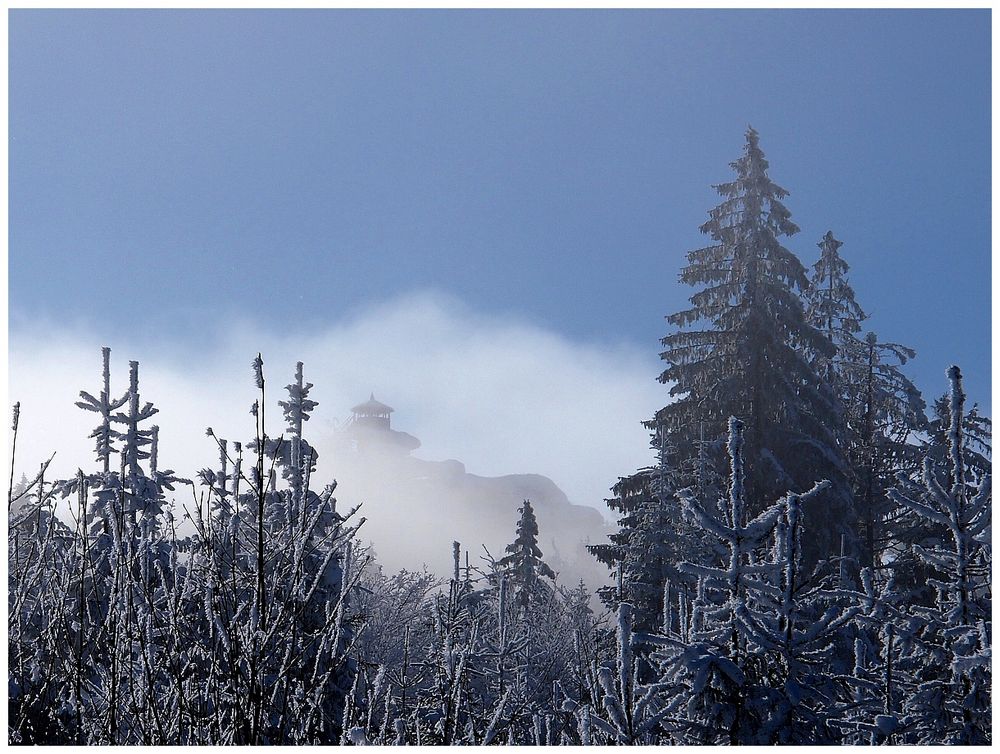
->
[9,10,991,414]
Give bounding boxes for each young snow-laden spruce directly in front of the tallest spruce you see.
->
[646,418,852,744]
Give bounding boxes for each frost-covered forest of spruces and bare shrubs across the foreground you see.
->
[8,128,992,745]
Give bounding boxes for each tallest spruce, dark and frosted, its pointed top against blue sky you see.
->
[650,128,855,563]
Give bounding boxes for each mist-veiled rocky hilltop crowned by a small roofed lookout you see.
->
[324,394,608,586]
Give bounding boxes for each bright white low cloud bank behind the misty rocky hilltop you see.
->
[10,294,666,572]
